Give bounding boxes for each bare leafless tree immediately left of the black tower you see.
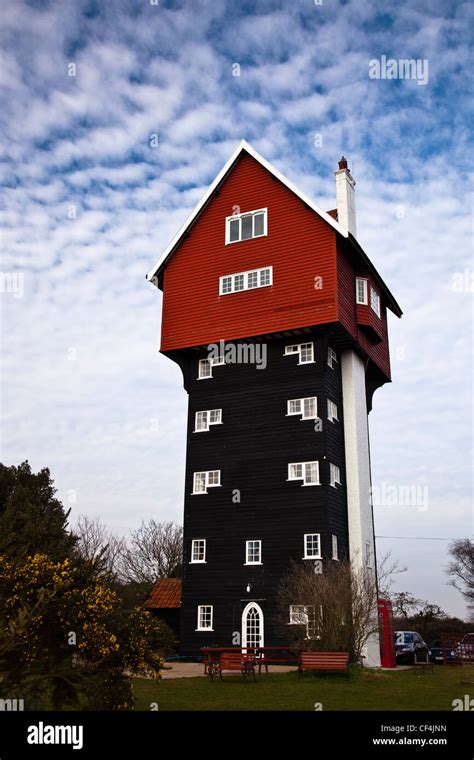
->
[120,519,183,584]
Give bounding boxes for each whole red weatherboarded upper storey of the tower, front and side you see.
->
[149,139,401,378]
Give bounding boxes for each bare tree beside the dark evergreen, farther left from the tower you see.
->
[73,515,123,579]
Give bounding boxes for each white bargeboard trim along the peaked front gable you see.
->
[146,140,349,280]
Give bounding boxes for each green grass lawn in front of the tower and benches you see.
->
[134,665,474,711]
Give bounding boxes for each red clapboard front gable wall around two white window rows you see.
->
[161,155,337,351]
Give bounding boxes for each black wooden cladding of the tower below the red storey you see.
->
[177,332,348,652]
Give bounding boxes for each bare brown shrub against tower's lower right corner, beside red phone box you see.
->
[278,560,378,661]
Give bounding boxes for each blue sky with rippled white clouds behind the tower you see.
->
[0,0,473,615]
